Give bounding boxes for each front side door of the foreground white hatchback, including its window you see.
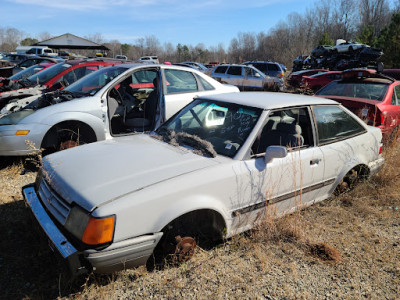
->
[231,107,325,231]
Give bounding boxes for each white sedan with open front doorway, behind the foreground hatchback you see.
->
[0,64,239,156]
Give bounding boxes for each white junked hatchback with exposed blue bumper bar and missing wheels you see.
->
[23,92,384,274]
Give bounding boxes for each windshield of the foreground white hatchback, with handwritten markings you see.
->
[157,99,262,157]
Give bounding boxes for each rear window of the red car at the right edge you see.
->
[316,81,389,101]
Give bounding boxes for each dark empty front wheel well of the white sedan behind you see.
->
[41,120,97,148]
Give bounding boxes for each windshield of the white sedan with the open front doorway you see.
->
[64,65,128,95]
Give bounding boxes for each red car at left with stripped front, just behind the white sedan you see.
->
[0,59,122,109]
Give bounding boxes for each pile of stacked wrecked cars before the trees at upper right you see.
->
[293,40,383,72]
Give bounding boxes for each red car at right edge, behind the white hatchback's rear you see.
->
[315,69,400,142]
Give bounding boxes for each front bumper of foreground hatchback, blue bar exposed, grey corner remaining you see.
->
[22,185,163,275]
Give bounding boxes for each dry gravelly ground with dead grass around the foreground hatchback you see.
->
[0,146,400,299]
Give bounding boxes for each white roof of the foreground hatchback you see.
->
[196,92,339,110]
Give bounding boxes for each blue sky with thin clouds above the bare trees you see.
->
[0,0,328,48]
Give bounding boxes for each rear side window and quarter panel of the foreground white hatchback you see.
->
[312,105,373,198]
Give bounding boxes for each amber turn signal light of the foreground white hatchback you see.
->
[82,216,115,245]
